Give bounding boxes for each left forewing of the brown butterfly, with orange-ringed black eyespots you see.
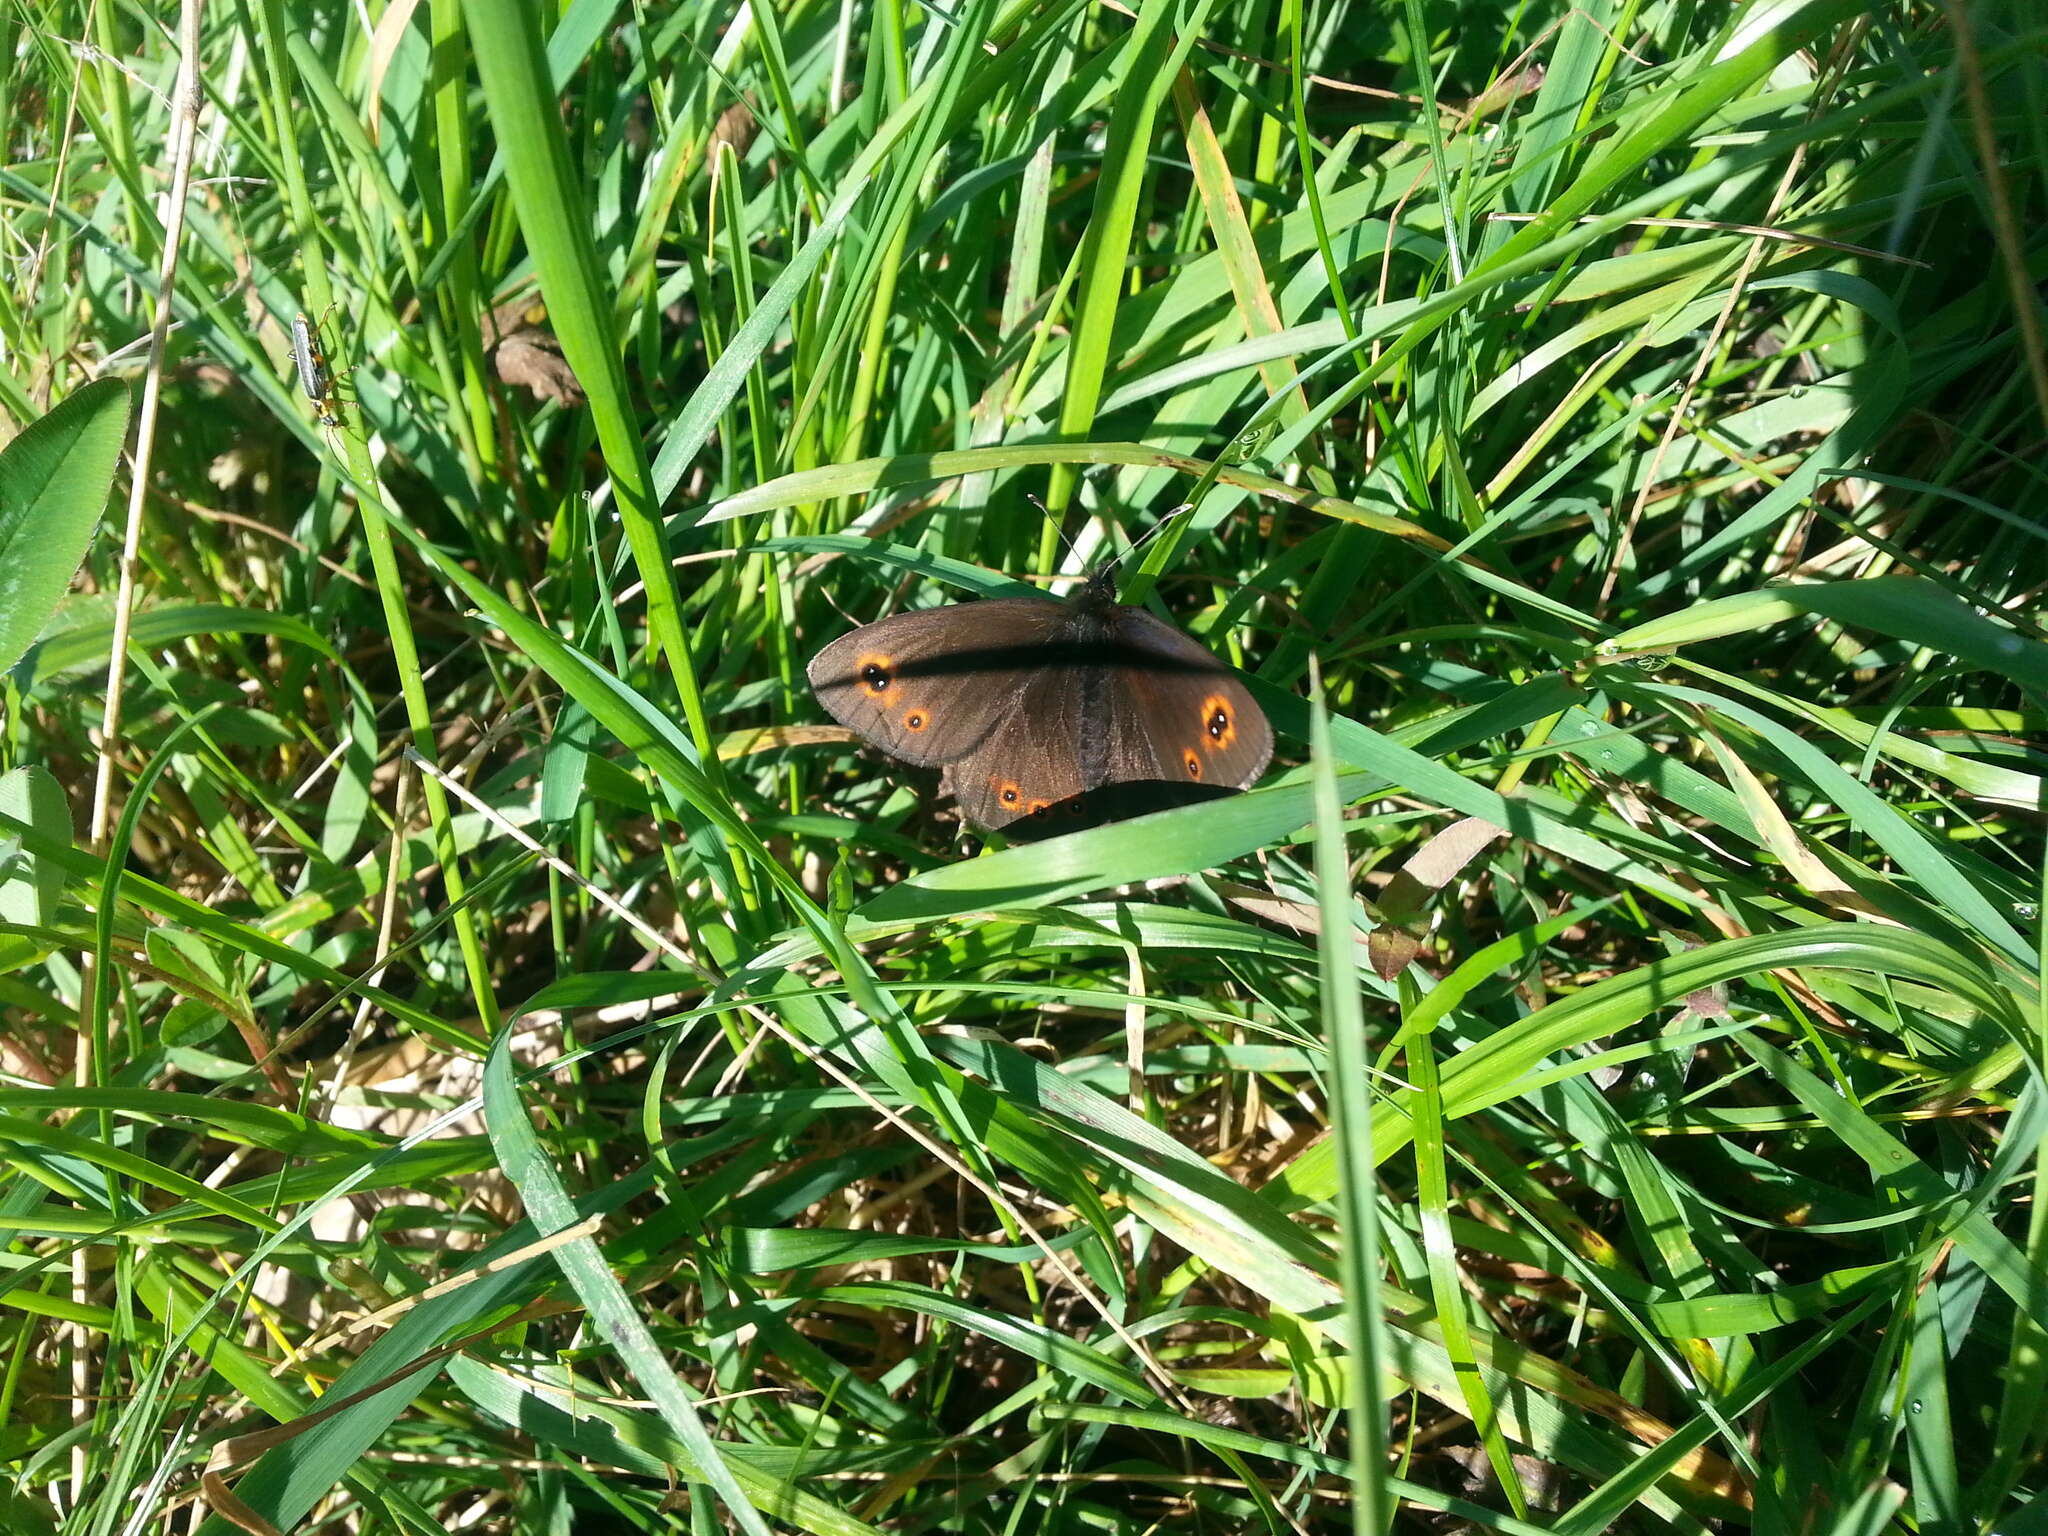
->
[809,598,1065,768]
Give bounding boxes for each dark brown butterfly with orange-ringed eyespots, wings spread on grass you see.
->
[809,571,1274,838]
